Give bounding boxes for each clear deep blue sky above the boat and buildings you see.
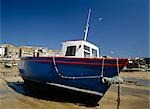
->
[0,0,150,57]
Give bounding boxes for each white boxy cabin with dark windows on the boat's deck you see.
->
[61,40,99,58]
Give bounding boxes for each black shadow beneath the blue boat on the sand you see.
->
[7,82,99,107]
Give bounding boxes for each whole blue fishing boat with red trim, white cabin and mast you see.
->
[19,10,128,102]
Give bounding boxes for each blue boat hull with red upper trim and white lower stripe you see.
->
[19,57,127,101]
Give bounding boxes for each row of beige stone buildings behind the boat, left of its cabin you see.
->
[0,44,60,59]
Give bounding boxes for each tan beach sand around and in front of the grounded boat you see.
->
[0,66,150,109]
